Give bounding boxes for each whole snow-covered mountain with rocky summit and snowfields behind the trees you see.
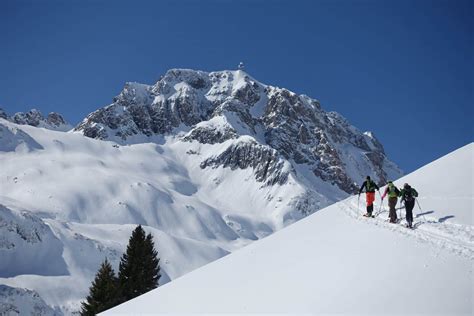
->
[0,69,401,314]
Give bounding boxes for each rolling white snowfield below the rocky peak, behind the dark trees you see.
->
[0,119,334,314]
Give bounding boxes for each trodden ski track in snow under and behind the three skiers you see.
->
[341,198,474,260]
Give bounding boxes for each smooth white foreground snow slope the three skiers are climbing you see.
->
[104,143,474,315]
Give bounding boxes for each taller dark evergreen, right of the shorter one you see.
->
[118,225,160,302]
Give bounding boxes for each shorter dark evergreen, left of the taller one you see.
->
[81,258,118,315]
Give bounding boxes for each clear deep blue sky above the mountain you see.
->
[0,0,474,172]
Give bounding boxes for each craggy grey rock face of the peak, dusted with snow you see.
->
[75,69,402,193]
